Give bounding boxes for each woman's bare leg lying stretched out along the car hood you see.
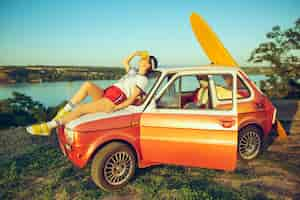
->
[59,98,115,125]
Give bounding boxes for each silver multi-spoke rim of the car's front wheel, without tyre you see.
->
[104,152,133,185]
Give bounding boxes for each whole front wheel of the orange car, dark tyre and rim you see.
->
[91,142,136,191]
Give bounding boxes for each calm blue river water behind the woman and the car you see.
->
[0,75,266,106]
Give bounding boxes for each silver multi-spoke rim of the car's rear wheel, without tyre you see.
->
[239,131,261,159]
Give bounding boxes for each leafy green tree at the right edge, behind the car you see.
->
[248,18,300,98]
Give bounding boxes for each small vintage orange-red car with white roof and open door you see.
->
[57,65,276,190]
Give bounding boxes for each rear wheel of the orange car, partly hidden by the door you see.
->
[238,126,263,160]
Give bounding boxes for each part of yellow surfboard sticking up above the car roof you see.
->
[190,13,238,66]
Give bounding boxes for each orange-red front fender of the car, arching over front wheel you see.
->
[57,113,158,168]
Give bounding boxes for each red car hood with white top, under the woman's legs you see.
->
[65,106,142,132]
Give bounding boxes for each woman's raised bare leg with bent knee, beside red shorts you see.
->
[70,81,104,105]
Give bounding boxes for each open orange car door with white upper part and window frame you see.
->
[140,72,237,170]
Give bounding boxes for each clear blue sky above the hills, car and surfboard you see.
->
[0,0,300,66]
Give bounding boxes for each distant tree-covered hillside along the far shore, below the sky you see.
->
[0,66,272,83]
